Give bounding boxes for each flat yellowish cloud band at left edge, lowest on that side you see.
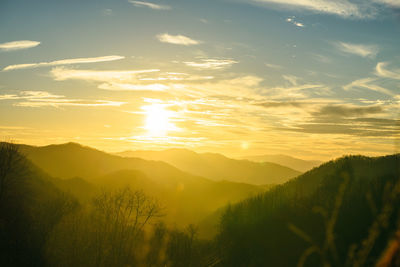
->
[0,91,125,107]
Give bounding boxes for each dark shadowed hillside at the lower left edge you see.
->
[0,146,78,266]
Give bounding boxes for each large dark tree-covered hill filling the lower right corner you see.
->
[217,154,400,266]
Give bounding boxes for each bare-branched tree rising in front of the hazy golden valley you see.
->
[93,188,162,266]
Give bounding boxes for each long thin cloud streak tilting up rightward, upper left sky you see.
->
[3,56,125,71]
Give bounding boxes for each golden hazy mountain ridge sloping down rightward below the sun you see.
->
[15,143,266,225]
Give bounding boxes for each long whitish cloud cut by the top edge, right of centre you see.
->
[251,0,371,18]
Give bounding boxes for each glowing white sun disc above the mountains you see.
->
[143,104,175,136]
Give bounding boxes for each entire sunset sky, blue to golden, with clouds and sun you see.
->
[0,0,400,160]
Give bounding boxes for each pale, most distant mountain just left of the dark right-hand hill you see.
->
[241,155,322,172]
